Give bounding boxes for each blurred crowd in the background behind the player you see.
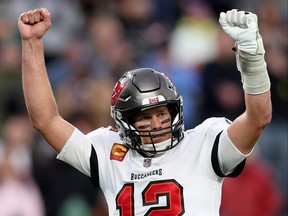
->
[0,0,288,216]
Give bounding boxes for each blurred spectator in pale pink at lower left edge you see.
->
[0,116,45,216]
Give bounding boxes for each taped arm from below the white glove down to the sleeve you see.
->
[228,36,272,154]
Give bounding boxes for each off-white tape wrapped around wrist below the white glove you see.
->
[236,35,271,95]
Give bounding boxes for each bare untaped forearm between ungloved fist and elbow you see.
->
[22,39,58,129]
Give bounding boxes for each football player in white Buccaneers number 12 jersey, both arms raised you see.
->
[18,8,271,216]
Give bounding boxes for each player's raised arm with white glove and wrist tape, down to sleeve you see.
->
[219,9,272,154]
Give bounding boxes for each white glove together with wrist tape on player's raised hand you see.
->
[219,9,270,94]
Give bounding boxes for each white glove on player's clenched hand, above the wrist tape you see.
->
[219,9,265,54]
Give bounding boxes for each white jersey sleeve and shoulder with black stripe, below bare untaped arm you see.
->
[57,127,121,187]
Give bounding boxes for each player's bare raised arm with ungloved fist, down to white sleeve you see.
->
[18,8,74,153]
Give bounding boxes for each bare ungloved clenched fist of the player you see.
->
[18,8,51,40]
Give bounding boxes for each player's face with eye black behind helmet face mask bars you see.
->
[134,106,171,144]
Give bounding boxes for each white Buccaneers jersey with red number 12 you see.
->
[57,118,245,216]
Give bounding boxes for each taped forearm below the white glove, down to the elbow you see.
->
[236,49,272,131]
